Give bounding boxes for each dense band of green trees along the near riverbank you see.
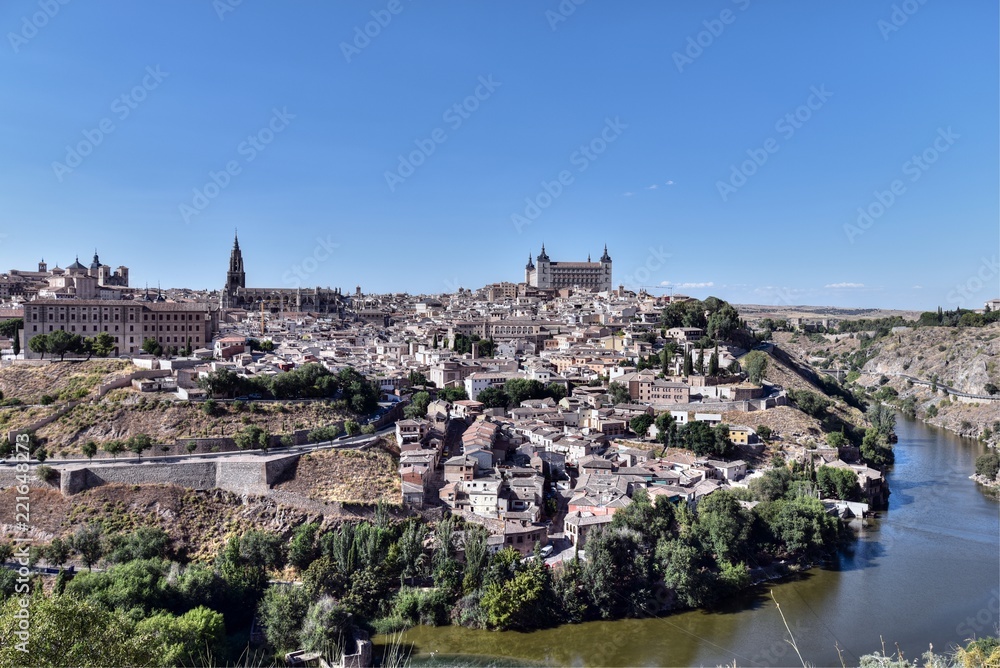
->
[0,478,842,665]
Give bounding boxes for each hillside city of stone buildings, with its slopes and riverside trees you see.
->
[0,237,1000,665]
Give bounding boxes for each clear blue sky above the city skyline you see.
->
[0,0,1000,309]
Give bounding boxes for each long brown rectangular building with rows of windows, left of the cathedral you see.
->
[22,299,217,359]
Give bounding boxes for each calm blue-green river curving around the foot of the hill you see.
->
[376,416,1000,666]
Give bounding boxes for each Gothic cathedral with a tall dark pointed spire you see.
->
[220,236,350,317]
